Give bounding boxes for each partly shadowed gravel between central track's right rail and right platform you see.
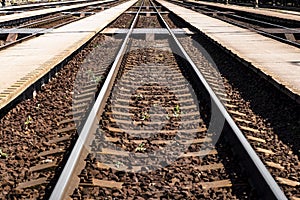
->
[180,36,300,198]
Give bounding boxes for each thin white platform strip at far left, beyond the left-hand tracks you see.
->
[0,0,115,24]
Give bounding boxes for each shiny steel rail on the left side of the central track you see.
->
[50,0,143,200]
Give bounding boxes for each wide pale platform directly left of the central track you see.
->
[0,0,137,109]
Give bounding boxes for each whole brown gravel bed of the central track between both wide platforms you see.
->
[0,2,300,199]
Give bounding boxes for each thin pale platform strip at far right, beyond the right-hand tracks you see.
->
[185,0,300,21]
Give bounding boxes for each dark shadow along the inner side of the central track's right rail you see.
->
[175,44,257,199]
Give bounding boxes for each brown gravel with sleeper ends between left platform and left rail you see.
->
[0,35,123,199]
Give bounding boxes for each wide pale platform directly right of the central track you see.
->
[158,0,300,102]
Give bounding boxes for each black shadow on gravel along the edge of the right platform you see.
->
[193,36,300,156]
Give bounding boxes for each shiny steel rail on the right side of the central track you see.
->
[151,1,287,200]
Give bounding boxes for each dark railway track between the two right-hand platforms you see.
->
[171,1,300,47]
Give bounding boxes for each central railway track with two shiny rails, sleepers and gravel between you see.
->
[50,2,286,199]
